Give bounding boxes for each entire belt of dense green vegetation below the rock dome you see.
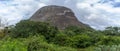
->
[0,20,120,51]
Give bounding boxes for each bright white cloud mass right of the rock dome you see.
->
[73,0,120,29]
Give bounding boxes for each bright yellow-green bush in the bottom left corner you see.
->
[0,38,27,51]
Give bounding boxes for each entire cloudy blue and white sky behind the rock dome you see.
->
[0,0,120,30]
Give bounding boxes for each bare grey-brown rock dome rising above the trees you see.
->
[30,5,88,29]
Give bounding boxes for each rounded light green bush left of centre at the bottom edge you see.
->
[24,35,46,51]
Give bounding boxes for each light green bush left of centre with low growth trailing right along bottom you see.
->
[25,36,77,51]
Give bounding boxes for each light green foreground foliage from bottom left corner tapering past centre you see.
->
[0,35,77,51]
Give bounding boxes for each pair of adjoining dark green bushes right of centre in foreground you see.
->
[54,34,92,48]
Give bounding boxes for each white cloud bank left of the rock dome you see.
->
[0,0,45,24]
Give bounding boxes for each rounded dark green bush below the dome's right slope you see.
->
[73,34,92,48]
